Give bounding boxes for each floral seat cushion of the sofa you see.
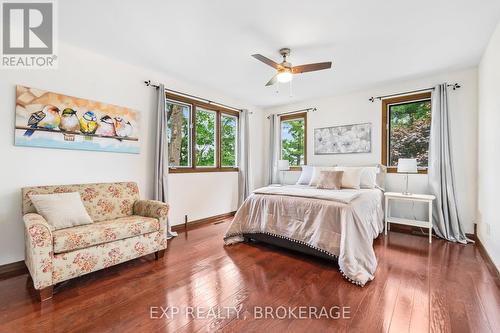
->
[52,215,160,253]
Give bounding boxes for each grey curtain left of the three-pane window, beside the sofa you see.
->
[153,84,177,239]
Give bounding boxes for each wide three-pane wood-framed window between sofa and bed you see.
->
[166,94,239,173]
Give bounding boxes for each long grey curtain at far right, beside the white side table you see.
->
[428,83,468,244]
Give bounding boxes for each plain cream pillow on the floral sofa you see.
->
[30,192,92,230]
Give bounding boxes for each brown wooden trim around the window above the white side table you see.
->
[381,92,432,174]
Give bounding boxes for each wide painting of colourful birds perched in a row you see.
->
[14,85,141,154]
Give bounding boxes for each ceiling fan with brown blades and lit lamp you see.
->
[252,48,332,86]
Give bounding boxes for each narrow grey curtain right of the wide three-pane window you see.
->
[238,110,250,206]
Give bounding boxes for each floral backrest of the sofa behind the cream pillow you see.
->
[22,182,139,222]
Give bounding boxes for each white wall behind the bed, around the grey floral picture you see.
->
[265,69,477,233]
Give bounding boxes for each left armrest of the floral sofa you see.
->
[23,213,54,289]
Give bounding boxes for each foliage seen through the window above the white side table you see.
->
[389,101,431,167]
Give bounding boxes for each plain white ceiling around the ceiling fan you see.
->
[58,0,500,107]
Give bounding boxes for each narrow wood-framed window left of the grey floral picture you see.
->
[280,113,307,170]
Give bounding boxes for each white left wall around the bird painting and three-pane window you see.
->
[0,43,263,265]
